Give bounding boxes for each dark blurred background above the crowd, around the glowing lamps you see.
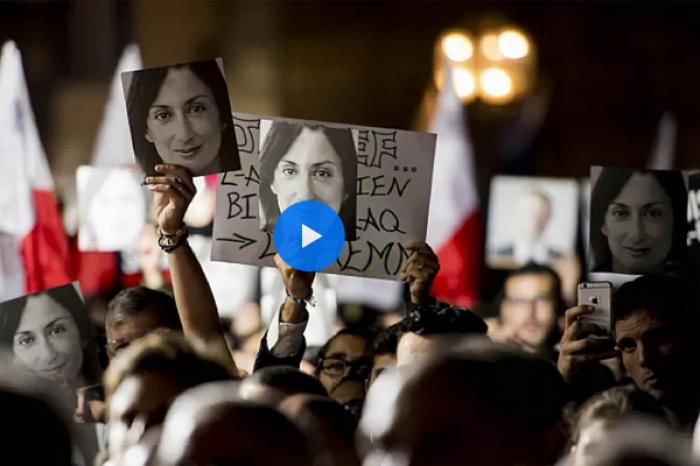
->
[0,1,700,294]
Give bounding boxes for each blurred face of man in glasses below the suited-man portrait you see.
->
[500,273,558,347]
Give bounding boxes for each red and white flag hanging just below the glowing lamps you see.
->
[427,65,482,306]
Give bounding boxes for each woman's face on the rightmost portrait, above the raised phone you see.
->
[601,173,674,274]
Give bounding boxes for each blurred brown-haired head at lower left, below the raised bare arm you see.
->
[104,332,234,457]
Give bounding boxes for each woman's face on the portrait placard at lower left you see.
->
[13,293,83,385]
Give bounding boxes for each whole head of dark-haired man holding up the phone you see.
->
[613,275,699,406]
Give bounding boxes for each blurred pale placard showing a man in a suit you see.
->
[487,176,578,268]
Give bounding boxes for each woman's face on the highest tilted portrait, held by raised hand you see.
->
[146,67,224,173]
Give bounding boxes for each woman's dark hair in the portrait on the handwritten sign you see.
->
[260,121,357,241]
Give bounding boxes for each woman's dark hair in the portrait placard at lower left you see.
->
[0,283,102,385]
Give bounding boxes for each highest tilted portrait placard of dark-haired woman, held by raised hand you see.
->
[123,60,241,176]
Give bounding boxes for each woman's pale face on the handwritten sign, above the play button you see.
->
[271,128,345,212]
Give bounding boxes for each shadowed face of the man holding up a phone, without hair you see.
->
[615,309,684,402]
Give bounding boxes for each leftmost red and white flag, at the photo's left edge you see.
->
[0,41,70,301]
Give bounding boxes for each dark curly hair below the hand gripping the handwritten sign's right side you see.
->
[399,302,487,339]
